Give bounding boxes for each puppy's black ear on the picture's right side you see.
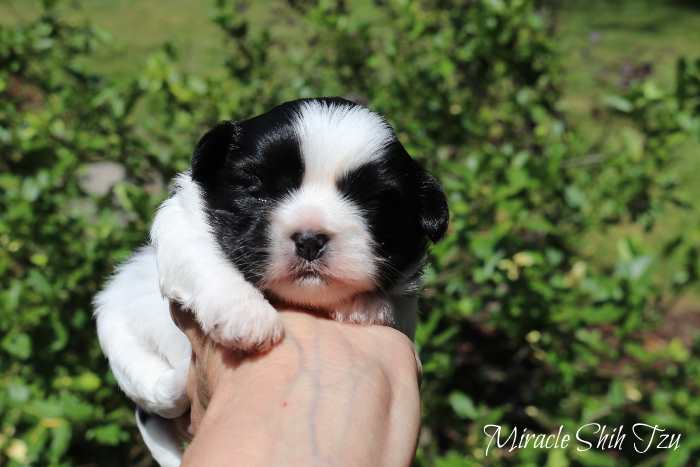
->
[417,167,450,243]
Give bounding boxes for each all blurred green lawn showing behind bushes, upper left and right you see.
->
[0,0,700,292]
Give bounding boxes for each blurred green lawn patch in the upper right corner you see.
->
[558,0,700,111]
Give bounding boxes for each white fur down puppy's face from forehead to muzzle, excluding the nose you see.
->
[264,101,392,308]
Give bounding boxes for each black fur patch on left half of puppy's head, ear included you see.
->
[192,106,304,283]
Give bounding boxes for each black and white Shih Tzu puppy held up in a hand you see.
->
[95,98,448,466]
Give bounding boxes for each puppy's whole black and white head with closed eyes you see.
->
[192,98,448,307]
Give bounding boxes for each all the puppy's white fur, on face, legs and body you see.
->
[95,102,416,465]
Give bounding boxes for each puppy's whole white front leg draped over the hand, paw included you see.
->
[151,173,284,350]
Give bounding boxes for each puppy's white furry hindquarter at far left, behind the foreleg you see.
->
[95,247,190,417]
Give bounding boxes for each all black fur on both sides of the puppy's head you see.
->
[192,98,448,289]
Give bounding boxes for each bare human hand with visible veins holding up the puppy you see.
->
[171,304,420,467]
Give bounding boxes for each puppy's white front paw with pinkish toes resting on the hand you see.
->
[203,298,284,353]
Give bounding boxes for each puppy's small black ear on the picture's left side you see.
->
[192,121,240,183]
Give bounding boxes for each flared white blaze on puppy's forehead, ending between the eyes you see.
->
[294,101,393,184]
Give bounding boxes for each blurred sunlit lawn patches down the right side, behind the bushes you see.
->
[557,0,700,293]
